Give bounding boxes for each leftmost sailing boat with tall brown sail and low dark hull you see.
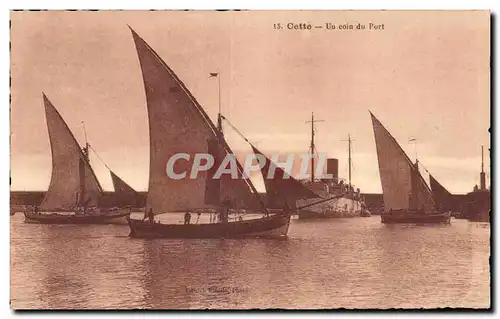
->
[24,94,130,224]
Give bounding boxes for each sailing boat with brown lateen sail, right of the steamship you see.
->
[370,112,450,224]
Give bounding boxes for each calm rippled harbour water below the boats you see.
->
[11,213,490,309]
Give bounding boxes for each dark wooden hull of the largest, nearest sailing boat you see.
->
[127,214,290,238]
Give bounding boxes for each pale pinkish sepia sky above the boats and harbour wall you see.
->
[11,11,490,193]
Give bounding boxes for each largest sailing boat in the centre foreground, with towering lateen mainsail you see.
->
[128,29,302,238]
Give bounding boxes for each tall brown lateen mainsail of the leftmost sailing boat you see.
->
[40,94,102,210]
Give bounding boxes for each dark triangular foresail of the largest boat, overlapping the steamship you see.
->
[252,146,320,207]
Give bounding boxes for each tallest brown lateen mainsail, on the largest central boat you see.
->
[131,29,256,213]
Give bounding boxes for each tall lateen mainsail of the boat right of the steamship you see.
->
[370,112,436,213]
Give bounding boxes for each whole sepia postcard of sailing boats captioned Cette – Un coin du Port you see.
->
[10,10,491,310]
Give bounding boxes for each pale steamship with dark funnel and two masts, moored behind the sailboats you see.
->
[297,114,371,219]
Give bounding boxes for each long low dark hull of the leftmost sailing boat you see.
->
[24,209,130,225]
